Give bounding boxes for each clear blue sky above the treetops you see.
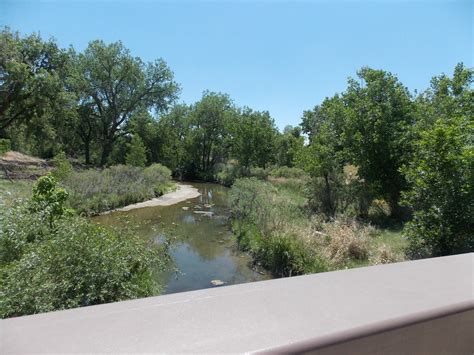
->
[0,0,474,128]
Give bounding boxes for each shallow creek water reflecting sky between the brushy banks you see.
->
[94,183,270,294]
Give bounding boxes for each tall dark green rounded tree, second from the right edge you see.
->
[344,68,414,218]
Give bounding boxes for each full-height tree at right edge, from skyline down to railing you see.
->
[403,63,474,256]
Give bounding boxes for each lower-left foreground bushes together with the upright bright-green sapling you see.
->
[0,176,168,318]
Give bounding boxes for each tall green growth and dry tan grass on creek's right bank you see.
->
[230,178,403,277]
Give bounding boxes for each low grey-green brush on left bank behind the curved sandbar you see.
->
[62,164,173,215]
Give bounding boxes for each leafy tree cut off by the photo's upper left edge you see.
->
[0,28,69,135]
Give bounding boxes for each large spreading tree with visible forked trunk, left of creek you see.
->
[72,41,178,165]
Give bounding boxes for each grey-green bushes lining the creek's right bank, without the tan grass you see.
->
[230,178,326,277]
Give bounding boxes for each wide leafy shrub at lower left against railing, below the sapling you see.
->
[0,216,165,317]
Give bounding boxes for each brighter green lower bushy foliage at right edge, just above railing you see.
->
[405,118,474,257]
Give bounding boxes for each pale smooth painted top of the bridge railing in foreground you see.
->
[0,253,474,354]
